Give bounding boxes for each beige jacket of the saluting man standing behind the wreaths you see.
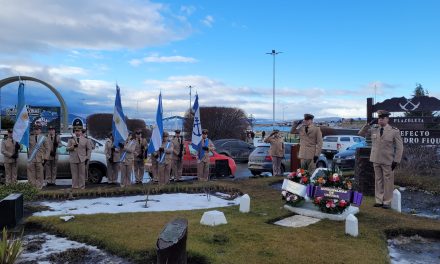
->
[290,124,322,159]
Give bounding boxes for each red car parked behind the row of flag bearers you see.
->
[145,141,237,177]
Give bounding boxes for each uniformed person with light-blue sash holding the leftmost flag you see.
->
[27,124,49,189]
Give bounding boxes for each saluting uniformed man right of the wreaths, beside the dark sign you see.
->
[359,110,403,209]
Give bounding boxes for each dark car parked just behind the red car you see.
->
[213,139,255,162]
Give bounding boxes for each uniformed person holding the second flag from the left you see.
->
[120,132,137,187]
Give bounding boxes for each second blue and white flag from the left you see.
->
[112,85,128,148]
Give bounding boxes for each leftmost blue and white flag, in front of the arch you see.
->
[12,80,29,148]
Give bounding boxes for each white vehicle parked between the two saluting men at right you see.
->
[321,135,365,159]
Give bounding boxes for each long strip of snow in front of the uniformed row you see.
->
[34,193,239,216]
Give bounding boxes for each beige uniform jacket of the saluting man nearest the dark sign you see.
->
[359,124,403,165]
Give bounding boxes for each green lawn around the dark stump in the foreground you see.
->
[27,178,440,263]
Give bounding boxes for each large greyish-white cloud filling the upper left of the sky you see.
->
[0,0,191,54]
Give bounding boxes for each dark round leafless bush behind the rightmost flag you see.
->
[184,106,249,140]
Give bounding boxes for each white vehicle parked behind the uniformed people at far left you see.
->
[0,135,107,183]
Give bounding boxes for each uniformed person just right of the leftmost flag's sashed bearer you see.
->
[44,126,61,186]
